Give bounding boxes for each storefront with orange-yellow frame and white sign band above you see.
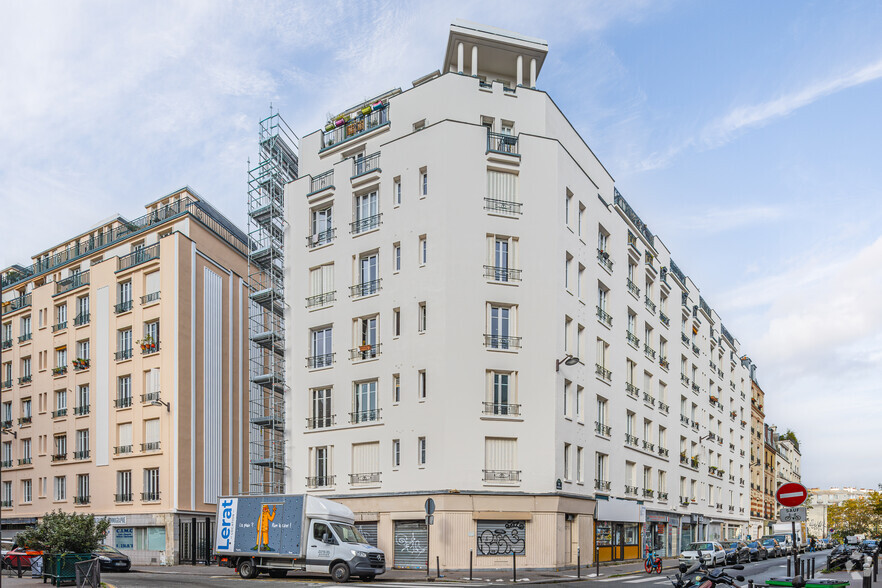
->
[594,498,646,561]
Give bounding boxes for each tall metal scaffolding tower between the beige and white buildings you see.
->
[248,107,299,494]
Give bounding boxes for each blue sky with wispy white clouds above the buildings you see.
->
[0,0,882,487]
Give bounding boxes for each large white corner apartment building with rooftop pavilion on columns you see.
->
[285,21,750,569]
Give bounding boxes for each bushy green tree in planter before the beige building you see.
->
[17,510,110,553]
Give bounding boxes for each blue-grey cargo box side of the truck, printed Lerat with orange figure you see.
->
[215,495,305,557]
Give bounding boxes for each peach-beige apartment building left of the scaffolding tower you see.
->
[0,188,249,564]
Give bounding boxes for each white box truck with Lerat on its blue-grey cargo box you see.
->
[214,494,386,582]
